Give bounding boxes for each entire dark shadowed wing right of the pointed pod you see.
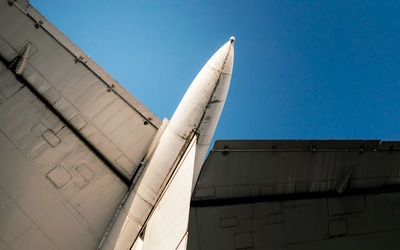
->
[188,140,400,250]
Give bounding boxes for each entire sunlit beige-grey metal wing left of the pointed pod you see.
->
[0,0,161,249]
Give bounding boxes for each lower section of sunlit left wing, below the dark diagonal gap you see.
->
[0,60,127,249]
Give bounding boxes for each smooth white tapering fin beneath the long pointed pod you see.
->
[142,137,197,250]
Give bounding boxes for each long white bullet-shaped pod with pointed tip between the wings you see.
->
[101,38,234,249]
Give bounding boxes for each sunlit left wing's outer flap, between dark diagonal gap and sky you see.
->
[0,0,161,180]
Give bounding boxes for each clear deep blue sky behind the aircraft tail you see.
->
[31,0,400,140]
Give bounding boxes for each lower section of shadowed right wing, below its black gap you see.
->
[188,192,400,250]
